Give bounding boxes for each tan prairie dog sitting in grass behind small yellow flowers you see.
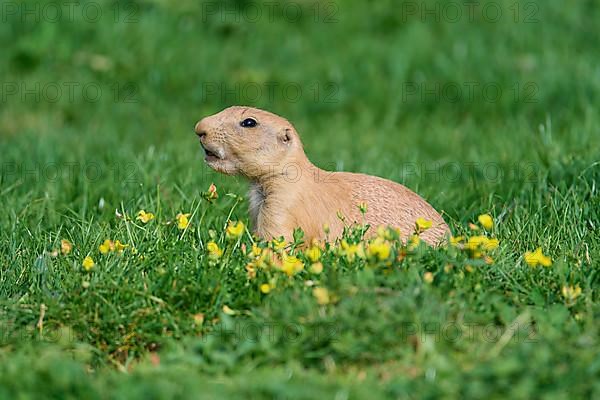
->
[195,106,449,244]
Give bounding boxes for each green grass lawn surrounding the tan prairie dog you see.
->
[0,0,600,399]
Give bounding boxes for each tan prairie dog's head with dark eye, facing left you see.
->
[194,106,302,178]
